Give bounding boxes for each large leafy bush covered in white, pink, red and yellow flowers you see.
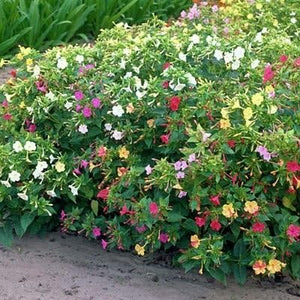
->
[0,0,300,283]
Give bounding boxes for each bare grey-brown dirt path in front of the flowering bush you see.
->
[0,233,300,300]
